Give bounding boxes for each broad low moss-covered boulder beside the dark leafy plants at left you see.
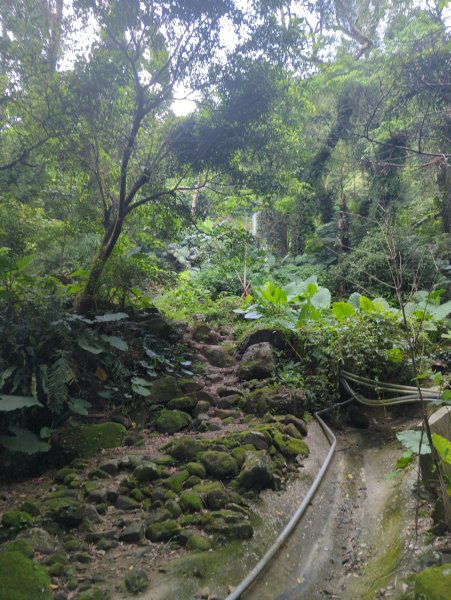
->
[69,423,127,457]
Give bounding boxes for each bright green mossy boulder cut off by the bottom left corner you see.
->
[0,551,53,600]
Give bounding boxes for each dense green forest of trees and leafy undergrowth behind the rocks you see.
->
[0,0,451,600]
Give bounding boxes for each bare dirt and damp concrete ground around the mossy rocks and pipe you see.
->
[0,316,451,600]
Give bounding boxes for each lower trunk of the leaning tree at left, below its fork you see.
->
[74,217,124,314]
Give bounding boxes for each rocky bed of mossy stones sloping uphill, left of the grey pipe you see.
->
[0,327,309,600]
